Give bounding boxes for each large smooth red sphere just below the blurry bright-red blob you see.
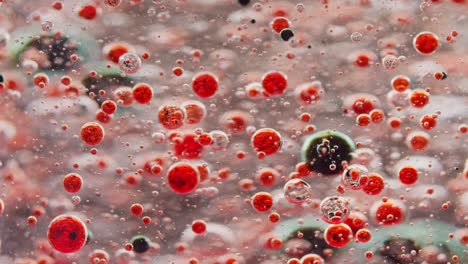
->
[167,163,200,194]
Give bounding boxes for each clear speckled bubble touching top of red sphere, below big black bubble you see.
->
[320,196,350,224]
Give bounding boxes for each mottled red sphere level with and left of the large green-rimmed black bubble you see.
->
[251,128,281,155]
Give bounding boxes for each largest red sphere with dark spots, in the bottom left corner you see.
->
[47,215,88,253]
